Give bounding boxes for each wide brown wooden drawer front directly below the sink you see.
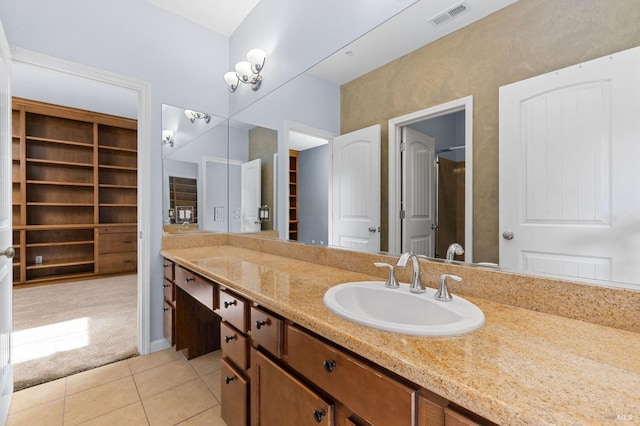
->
[286,325,417,425]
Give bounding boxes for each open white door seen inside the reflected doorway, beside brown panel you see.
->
[402,127,437,257]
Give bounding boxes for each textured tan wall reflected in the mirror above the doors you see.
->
[341,0,640,262]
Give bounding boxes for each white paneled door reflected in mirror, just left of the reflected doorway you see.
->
[329,124,380,252]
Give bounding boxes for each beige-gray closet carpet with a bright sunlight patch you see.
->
[12,275,138,390]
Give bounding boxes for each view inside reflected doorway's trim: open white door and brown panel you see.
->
[401,111,465,260]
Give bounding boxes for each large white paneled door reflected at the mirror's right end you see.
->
[499,48,640,284]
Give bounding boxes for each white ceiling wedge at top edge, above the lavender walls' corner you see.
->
[147,0,260,37]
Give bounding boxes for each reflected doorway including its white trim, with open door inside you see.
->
[389,96,473,262]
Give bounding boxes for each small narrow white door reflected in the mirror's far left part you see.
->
[240,158,262,232]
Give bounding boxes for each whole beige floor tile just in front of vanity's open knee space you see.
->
[133,359,198,399]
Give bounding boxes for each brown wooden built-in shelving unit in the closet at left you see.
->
[12,98,137,284]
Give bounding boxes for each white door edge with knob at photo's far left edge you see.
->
[0,17,13,424]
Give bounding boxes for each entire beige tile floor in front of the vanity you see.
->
[7,349,226,426]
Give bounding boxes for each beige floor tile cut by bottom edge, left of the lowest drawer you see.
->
[142,378,218,426]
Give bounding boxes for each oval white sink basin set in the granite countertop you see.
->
[323,281,484,336]
